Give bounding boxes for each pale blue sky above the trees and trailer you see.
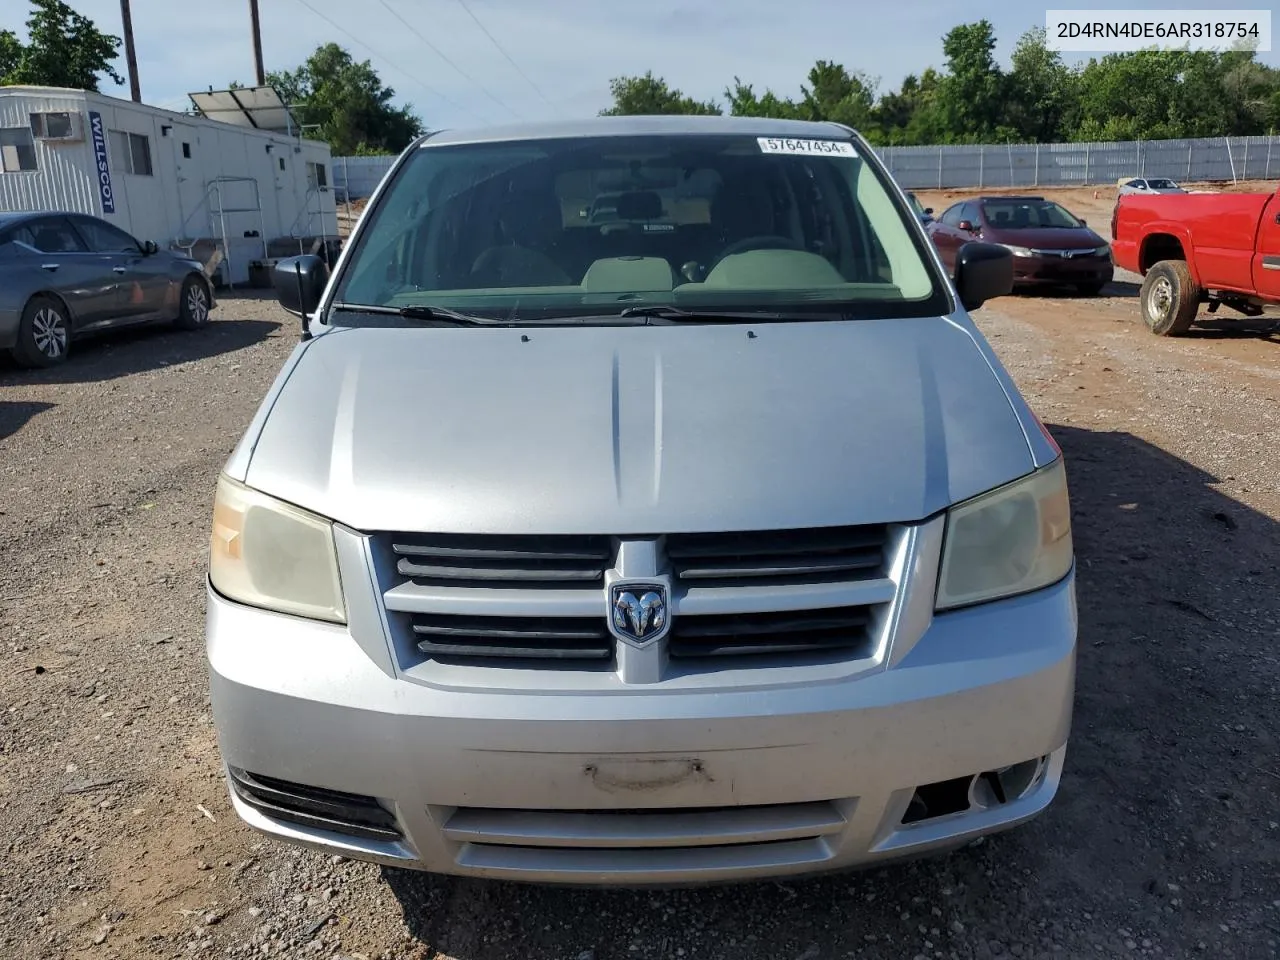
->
[12,0,1280,128]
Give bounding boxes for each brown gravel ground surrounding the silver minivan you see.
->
[0,282,1280,960]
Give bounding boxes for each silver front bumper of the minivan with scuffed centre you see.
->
[207,563,1076,884]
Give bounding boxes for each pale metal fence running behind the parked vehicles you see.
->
[333,137,1280,200]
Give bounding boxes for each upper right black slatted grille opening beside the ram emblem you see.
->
[667,525,887,586]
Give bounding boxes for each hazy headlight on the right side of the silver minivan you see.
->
[936,457,1074,611]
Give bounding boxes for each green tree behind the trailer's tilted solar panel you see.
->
[254,44,425,156]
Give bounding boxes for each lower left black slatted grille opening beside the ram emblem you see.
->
[411,612,613,660]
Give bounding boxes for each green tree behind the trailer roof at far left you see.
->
[0,0,124,91]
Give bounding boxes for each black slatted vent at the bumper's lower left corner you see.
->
[228,767,403,840]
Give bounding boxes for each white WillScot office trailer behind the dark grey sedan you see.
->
[0,87,338,284]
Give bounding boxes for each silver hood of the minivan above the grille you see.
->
[246,317,1034,535]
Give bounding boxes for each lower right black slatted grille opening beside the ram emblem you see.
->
[667,607,870,658]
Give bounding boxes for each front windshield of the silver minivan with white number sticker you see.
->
[330,134,950,324]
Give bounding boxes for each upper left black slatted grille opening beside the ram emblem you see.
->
[390,535,613,588]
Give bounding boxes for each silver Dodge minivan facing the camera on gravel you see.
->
[207,116,1076,884]
